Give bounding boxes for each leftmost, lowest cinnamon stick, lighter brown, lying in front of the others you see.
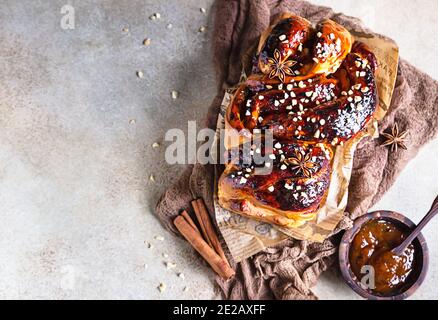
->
[173,216,235,279]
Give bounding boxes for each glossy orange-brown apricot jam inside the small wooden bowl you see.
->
[349,219,415,296]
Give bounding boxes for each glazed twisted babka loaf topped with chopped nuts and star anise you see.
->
[218,14,378,227]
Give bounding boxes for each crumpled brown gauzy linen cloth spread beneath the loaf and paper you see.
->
[156,0,438,299]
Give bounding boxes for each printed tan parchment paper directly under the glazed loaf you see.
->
[214,31,398,262]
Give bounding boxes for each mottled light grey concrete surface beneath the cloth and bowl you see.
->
[0,0,438,299]
